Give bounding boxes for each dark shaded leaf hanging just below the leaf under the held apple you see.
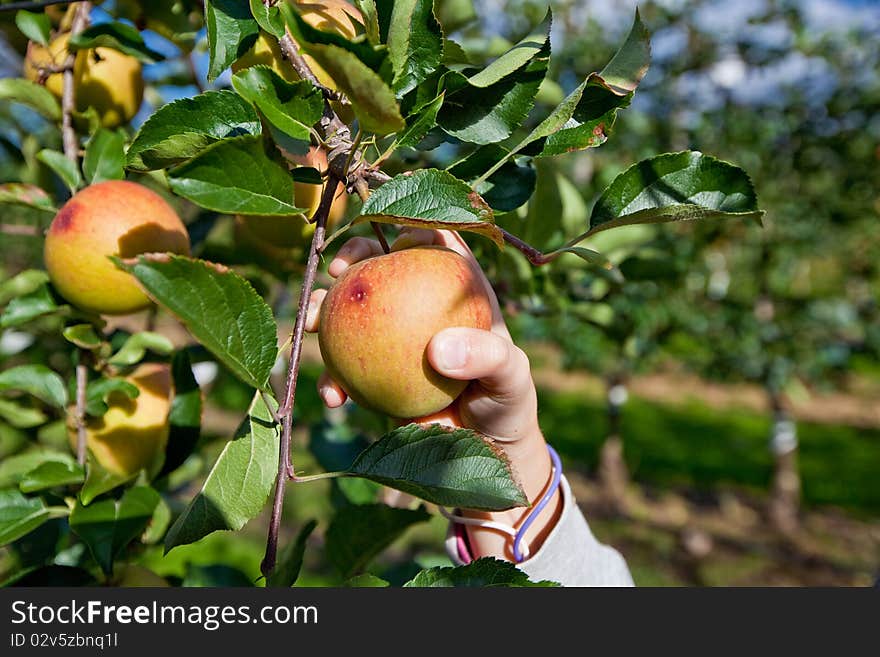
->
[324,504,431,579]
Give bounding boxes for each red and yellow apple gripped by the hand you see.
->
[318,246,492,418]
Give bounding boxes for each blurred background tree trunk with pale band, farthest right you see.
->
[768,391,801,535]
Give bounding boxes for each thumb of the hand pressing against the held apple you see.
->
[427,328,534,400]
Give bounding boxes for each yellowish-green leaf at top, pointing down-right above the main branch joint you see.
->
[308,45,406,135]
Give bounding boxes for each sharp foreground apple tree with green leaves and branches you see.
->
[0,0,761,586]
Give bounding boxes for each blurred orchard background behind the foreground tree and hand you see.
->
[0,0,880,586]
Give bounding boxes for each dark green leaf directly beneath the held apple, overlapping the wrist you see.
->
[348,424,528,510]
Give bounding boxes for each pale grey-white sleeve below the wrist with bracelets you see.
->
[446,476,634,586]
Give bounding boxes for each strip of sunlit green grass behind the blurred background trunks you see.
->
[539,391,880,515]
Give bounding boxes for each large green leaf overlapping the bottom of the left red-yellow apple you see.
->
[117,255,278,388]
